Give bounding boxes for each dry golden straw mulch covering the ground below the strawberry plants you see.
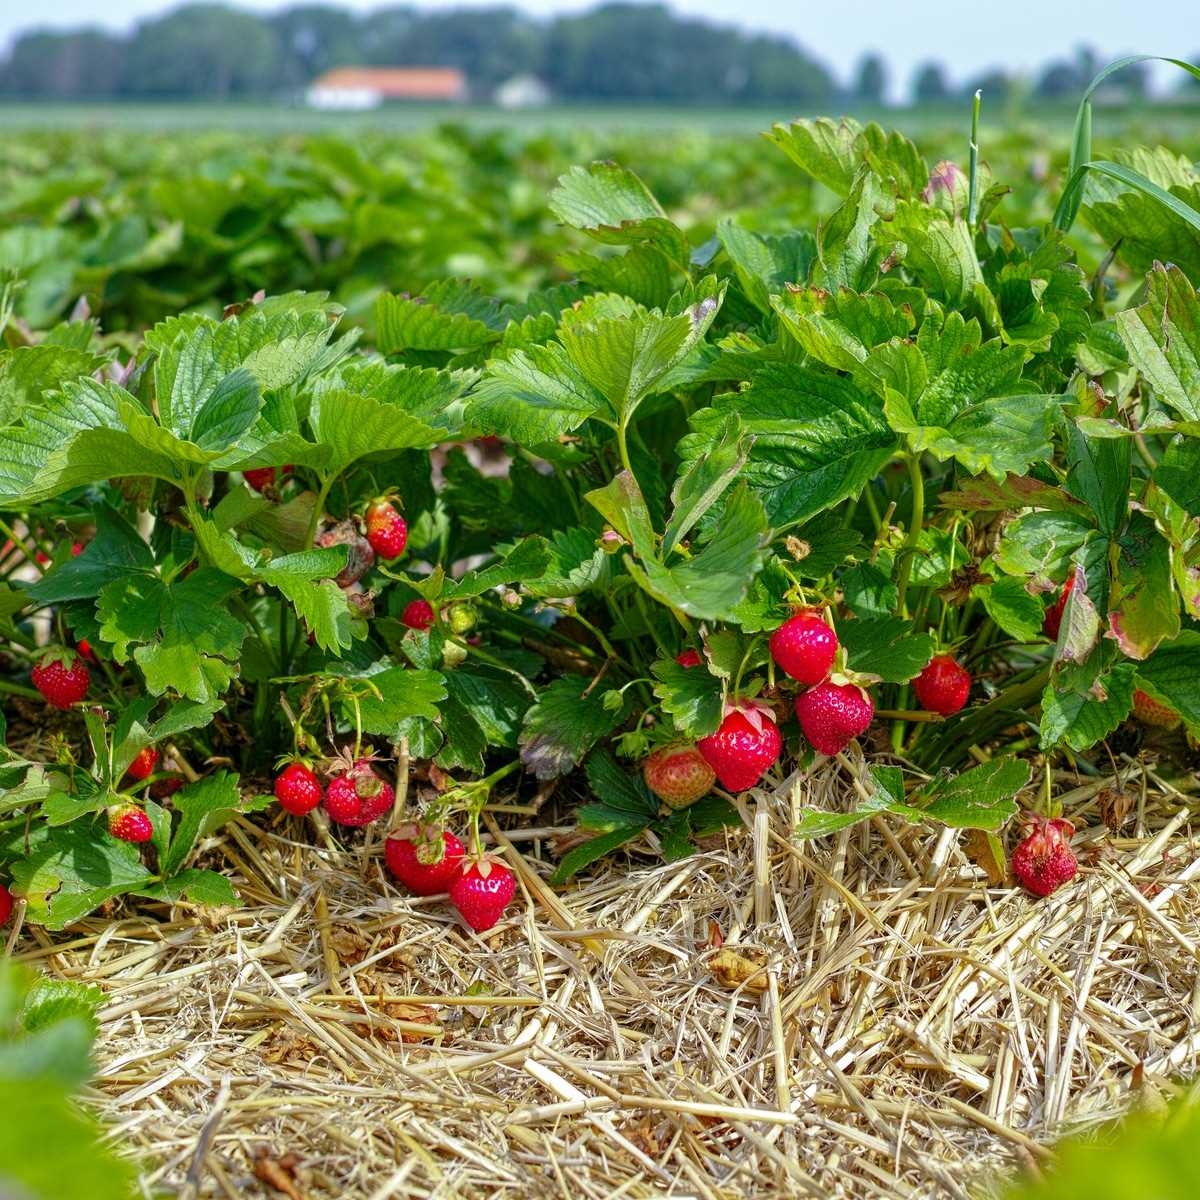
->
[9,760,1200,1200]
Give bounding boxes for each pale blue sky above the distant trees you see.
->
[0,0,1200,94]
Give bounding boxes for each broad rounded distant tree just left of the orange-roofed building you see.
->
[122,4,281,98]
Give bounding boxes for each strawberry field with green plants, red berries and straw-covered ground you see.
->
[7,64,1200,1200]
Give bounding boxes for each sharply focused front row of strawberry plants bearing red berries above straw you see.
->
[0,91,1200,928]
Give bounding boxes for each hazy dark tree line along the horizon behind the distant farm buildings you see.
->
[0,2,1190,104]
